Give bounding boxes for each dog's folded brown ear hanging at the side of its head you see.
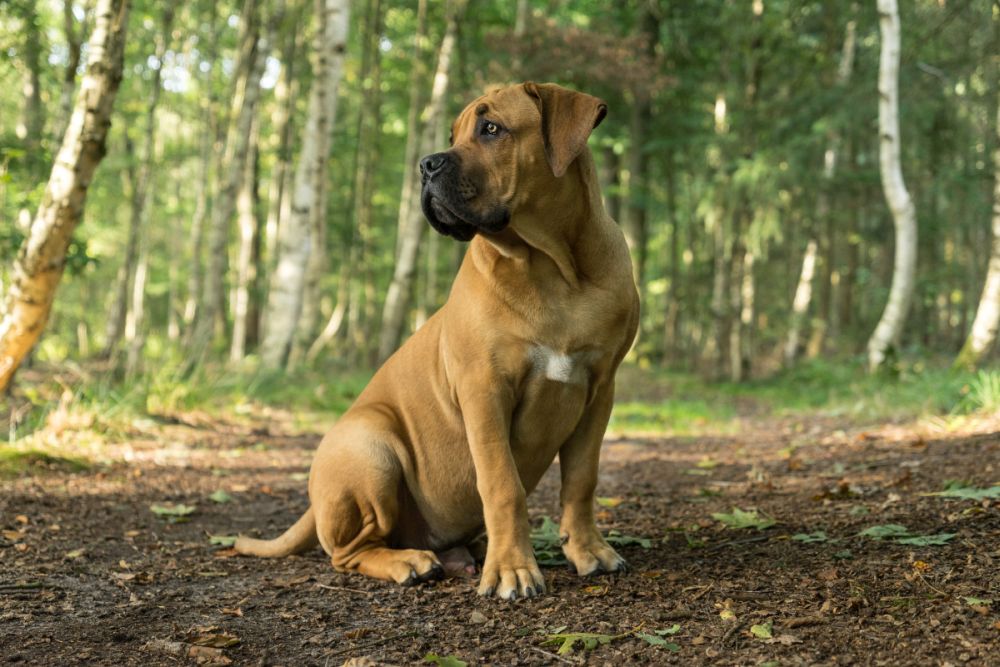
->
[524,82,608,178]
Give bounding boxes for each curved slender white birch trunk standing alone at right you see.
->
[868,0,917,371]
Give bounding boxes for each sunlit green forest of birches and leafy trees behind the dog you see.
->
[0,0,1000,433]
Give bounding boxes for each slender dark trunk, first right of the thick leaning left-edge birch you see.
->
[101,4,174,359]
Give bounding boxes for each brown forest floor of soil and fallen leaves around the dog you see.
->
[0,368,1000,666]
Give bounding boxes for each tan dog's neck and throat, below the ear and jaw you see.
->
[470,150,614,288]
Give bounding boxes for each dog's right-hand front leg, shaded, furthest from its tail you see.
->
[559,384,626,576]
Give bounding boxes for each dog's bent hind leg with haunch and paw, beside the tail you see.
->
[309,425,444,586]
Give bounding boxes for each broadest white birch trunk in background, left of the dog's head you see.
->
[260,0,350,368]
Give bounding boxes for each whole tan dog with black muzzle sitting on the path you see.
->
[236,83,639,599]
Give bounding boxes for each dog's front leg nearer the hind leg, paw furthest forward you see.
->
[462,395,545,600]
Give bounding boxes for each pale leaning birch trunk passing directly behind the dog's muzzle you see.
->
[378,0,465,363]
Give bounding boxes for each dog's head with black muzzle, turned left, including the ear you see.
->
[420,83,607,241]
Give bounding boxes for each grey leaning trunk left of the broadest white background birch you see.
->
[184,0,281,373]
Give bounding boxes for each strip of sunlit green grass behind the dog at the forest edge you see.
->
[8,358,1000,446]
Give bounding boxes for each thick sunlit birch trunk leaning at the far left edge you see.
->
[0,0,129,392]
